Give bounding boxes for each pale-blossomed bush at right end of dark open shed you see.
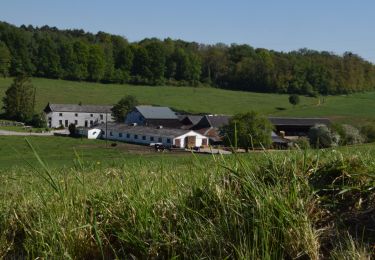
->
[309,124,340,148]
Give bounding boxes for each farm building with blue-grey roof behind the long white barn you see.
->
[125,106,181,128]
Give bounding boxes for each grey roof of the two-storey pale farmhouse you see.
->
[45,104,113,113]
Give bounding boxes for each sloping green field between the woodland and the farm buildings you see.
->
[0,78,375,123]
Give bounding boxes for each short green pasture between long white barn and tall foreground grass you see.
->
[0,136,194,170]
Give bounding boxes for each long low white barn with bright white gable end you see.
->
[87,123,208,148]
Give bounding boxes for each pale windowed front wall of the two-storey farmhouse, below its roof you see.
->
[46,112,114,128]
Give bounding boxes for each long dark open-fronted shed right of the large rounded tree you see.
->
[268,117,331,136]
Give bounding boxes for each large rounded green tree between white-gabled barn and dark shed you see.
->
[221,112,273,150]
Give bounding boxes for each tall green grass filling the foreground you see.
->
[0,144,375,259]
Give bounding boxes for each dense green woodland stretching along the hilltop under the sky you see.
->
[0,22,375,95]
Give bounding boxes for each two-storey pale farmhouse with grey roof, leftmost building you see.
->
[43,103,113,128]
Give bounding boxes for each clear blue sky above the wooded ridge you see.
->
[0,0,375,63]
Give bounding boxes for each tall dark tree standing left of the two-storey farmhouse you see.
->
[3,75,35,122]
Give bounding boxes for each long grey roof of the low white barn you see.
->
[93,123,198,138]
